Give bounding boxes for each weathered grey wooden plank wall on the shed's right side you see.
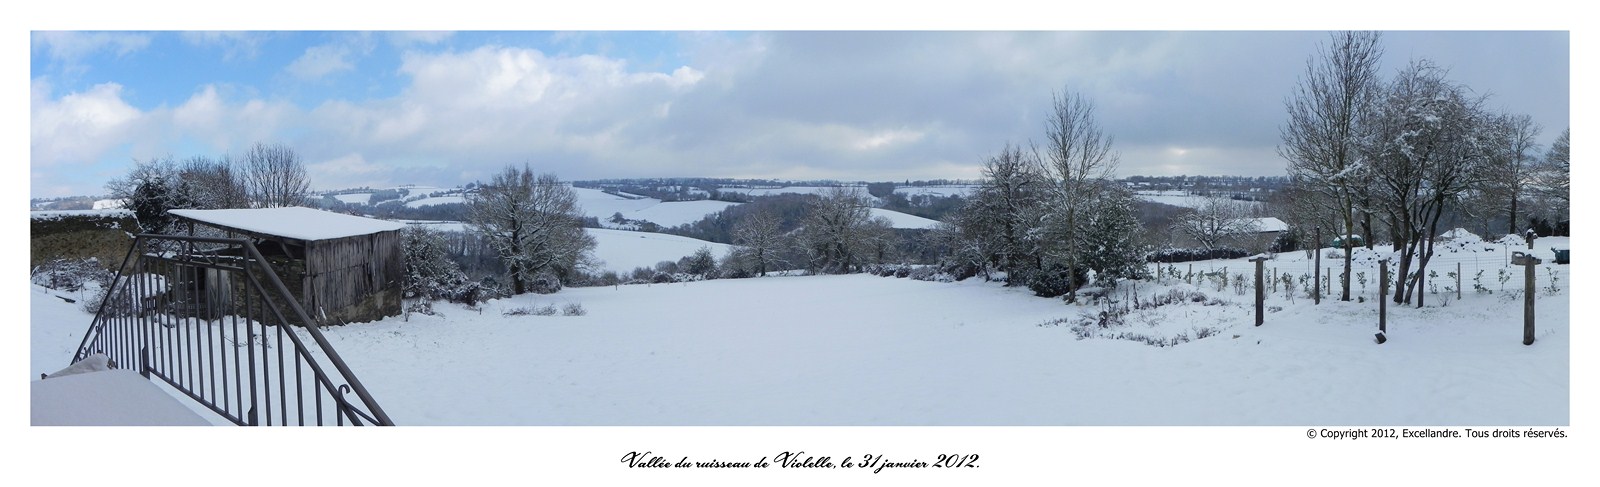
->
[304,231,405,320]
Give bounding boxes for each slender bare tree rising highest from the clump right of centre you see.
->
[1038,91,1118,303]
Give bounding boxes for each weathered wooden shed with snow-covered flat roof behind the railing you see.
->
[170,207,405,325]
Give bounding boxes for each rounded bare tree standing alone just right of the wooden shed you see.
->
[467,165,595,295]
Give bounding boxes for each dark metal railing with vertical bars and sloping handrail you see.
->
[74,234,394,426]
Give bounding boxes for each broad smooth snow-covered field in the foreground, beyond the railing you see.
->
[32,232,1571,425]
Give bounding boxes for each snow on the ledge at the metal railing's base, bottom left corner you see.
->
[29,370,211,426]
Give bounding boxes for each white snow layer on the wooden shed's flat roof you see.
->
[168,207,405,240]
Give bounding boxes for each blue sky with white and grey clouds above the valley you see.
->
[29,30,1570,197]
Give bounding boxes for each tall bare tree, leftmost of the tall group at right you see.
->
[1278,32,1382,301]
